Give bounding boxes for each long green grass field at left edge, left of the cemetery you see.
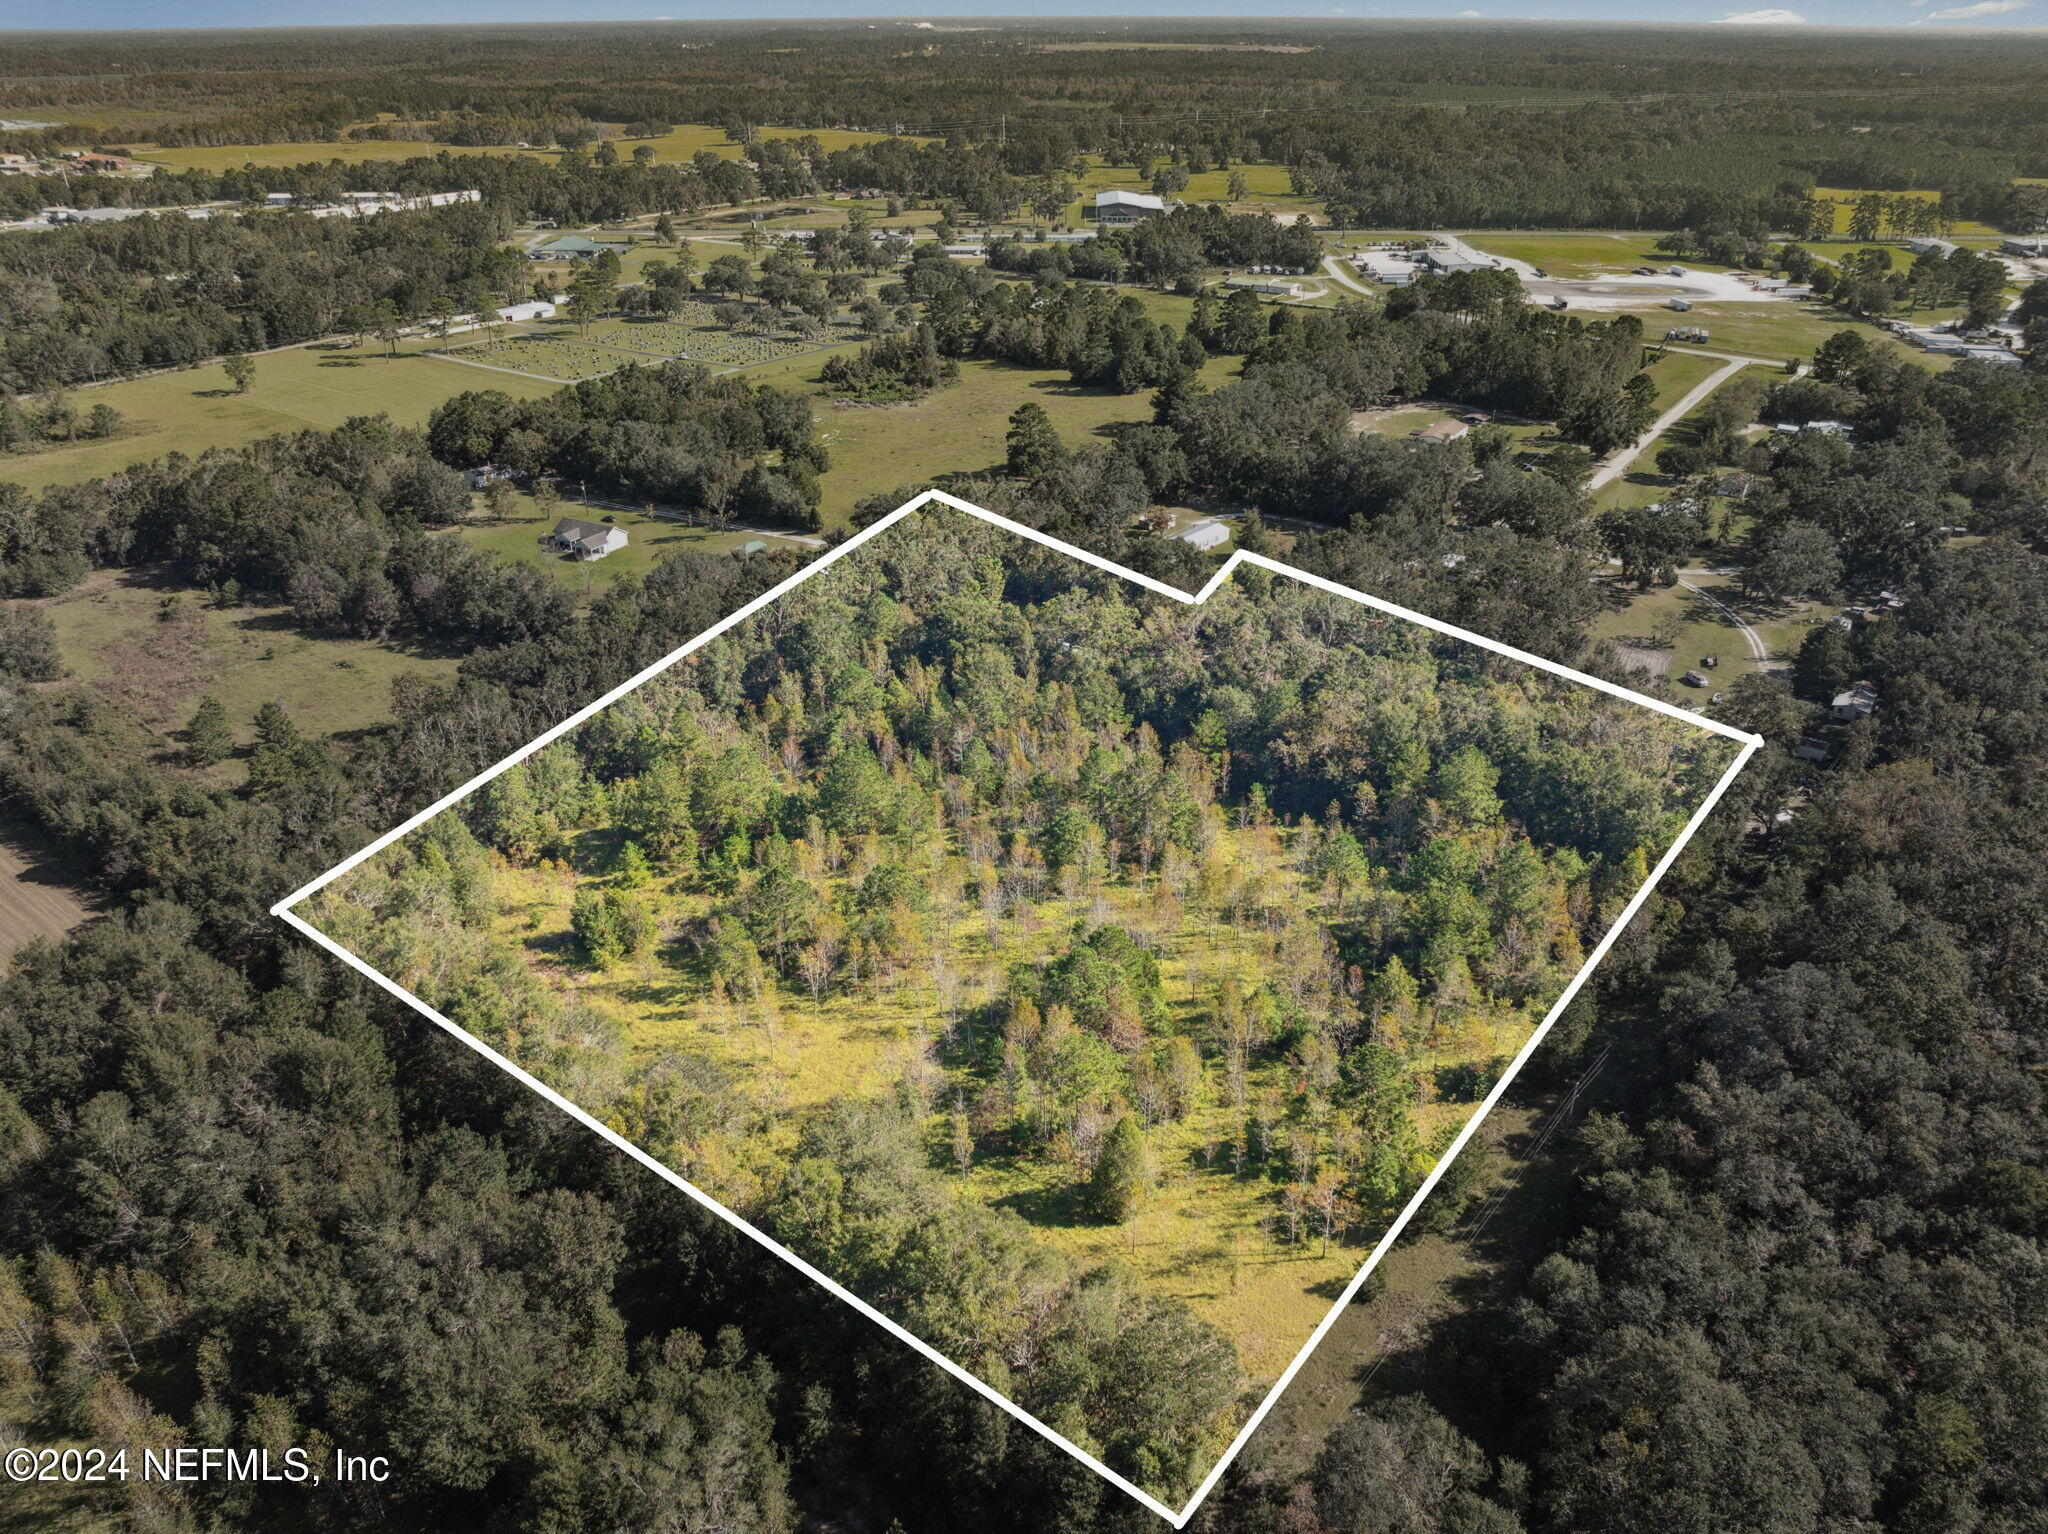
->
[0,340,561,489]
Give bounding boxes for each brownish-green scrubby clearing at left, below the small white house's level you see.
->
[35,569,459,784]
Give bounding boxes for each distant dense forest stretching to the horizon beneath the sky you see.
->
[0,20,2048,231]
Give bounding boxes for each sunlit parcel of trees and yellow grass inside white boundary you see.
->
[305,508,1733,1501]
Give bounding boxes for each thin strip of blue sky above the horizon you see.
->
[16,0,2048,31]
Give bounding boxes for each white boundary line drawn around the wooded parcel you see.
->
[270,489,1763,1528]
